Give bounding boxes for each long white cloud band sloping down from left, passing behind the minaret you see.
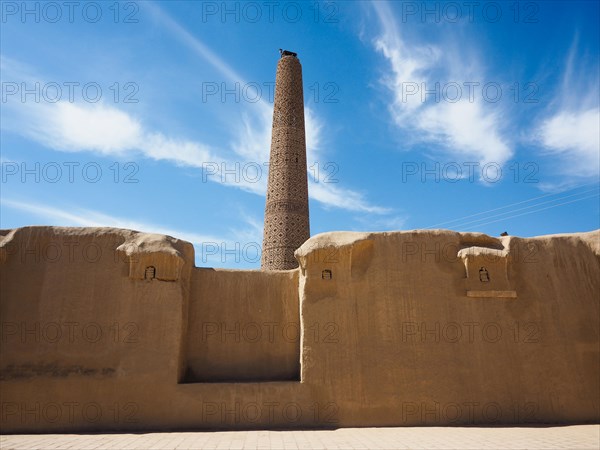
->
[7,89,388,214]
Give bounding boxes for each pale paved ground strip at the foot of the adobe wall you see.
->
[0,425,600,450]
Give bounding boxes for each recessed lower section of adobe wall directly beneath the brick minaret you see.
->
[185,269,300,382]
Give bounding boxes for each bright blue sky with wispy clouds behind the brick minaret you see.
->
[0,1,600,268]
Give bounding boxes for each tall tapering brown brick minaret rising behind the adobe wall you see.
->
[261,51,310,270]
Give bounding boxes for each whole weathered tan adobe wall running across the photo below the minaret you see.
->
[0,227,600,433]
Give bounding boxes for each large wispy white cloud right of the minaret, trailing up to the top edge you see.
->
[370,1,513,171]
